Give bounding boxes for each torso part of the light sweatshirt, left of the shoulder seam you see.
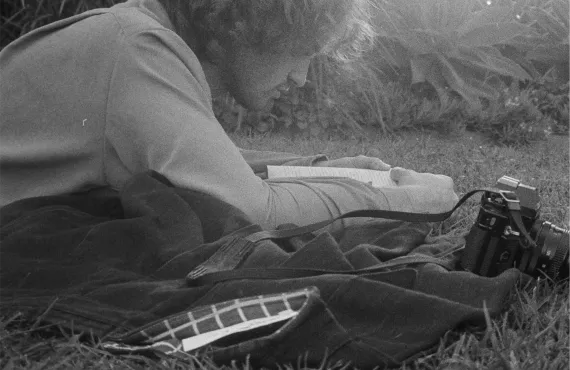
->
[0,3,154,205]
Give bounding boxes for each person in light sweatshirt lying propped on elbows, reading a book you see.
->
[0,0,457,229]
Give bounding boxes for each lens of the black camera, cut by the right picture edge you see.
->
[526,220,570,279]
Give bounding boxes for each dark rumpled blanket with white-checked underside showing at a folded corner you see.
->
[0,172,521,369]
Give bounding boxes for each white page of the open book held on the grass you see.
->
[267,166,397,188]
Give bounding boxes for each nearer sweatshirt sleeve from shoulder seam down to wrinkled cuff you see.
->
[105,29,404,229]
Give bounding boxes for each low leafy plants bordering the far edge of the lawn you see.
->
[213,73,570,146]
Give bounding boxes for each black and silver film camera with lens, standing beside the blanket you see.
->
[461,176,570,279]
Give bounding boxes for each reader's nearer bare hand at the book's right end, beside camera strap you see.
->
[390,167,459,213]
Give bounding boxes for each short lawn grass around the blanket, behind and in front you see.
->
[0,132,570,370]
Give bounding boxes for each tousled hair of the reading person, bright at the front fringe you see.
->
[160,0,374,60]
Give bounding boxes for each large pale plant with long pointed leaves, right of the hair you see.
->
[367,0,533,107]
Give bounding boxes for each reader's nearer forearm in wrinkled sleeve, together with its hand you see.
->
[242,174,458,234]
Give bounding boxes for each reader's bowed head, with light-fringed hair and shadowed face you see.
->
[160,0,373,110]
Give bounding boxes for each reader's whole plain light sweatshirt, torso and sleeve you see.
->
[0,0,418,229]
